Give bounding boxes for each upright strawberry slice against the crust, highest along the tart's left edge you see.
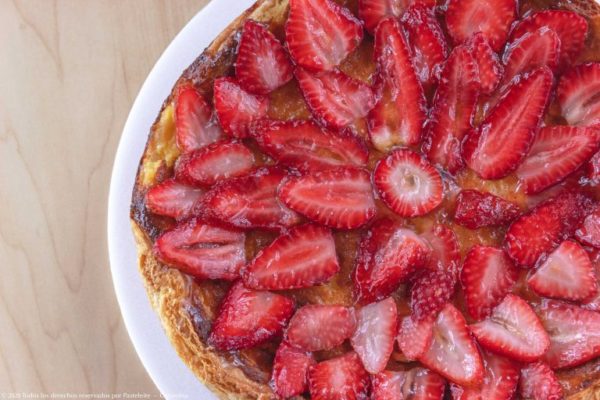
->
[175,85,222,153]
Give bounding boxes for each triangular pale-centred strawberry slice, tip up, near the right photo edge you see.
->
[527,240,598,301]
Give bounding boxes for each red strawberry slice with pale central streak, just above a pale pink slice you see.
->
[460,246,519,320]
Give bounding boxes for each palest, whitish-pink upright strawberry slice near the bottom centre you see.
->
[351,297,398,374]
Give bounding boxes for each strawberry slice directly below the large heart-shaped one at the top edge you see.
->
[296,68,375,128]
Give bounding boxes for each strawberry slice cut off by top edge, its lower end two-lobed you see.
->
[446,0,517,51]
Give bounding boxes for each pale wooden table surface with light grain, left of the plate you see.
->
[0,0,208,398]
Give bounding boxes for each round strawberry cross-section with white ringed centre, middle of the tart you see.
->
[373,149,444,217]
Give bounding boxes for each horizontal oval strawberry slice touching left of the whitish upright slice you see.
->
[286,304,356,351]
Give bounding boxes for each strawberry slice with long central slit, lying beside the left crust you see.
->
[153,218,246,280]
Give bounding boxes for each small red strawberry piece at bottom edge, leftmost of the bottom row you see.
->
[271,342,316,399]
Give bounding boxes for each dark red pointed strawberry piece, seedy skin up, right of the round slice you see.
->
[454,189,521,229]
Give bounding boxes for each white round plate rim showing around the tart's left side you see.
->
[108,0,254,400]
